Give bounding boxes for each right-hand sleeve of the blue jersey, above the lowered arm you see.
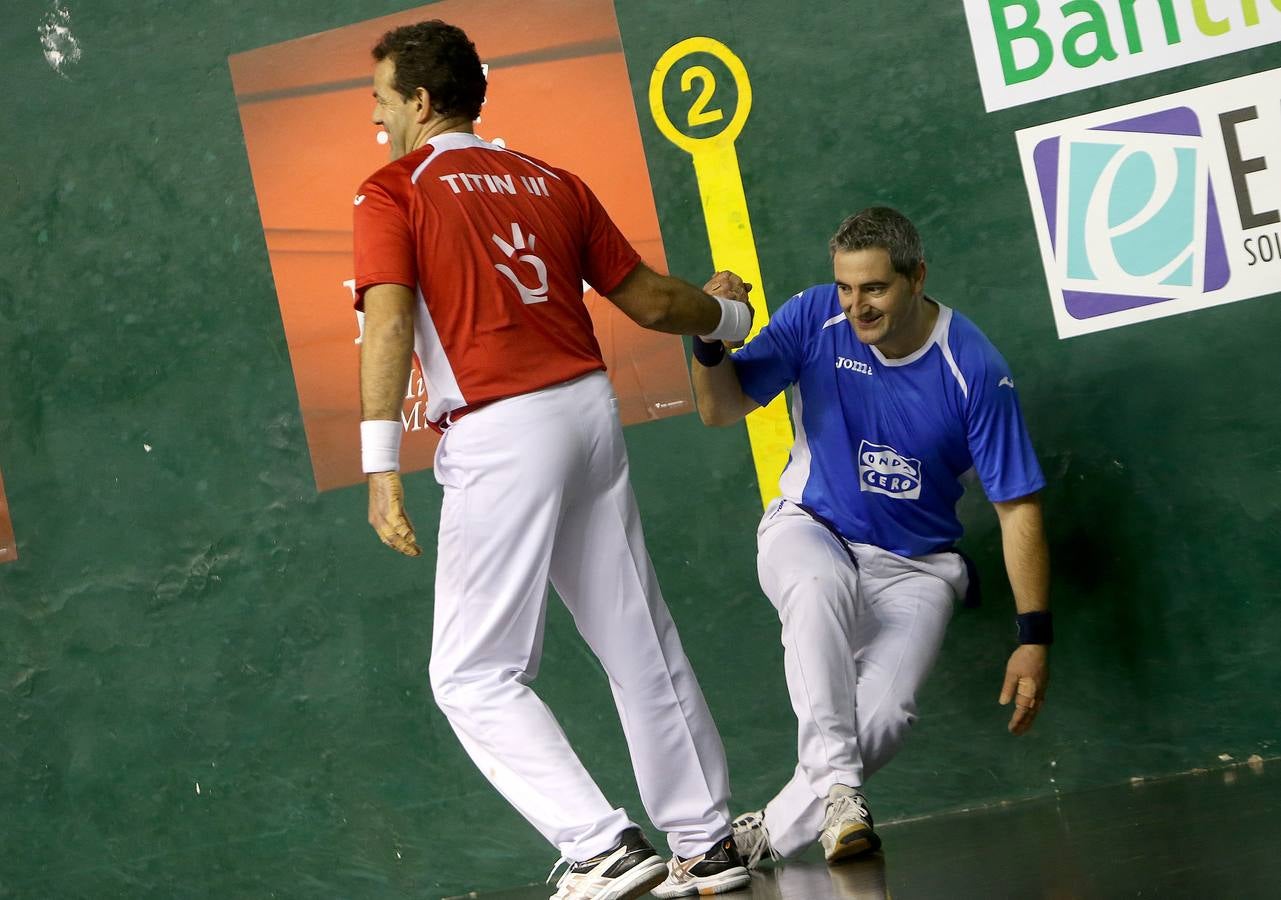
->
[966,348,1045,503]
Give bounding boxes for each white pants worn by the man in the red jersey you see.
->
[430,373,729,862]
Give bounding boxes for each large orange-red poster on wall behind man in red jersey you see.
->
[229,0,691,490]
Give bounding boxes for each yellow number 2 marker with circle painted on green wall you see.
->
[649,37,792,514]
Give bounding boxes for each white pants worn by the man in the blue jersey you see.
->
[757,501,967,856]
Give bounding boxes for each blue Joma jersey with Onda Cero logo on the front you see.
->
[731,284,1045,557]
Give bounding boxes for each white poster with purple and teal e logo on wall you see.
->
[1017,69,1281,338]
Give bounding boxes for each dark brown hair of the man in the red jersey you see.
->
[371,19,485,120]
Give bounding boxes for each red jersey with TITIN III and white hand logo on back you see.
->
[355,132,641,422]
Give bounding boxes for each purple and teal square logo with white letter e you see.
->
[1032,106,1230,320]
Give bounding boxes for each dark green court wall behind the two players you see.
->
[0,0,1281,897]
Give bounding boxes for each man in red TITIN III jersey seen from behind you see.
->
[355,20,752,900]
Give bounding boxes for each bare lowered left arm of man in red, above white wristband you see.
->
[360,284,414,421]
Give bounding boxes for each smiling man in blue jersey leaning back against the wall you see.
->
[693,207,1052,864]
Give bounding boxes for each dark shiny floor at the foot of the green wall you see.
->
[470,762,1281,900]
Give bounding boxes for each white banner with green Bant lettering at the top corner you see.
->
[965,0,1281,113]
